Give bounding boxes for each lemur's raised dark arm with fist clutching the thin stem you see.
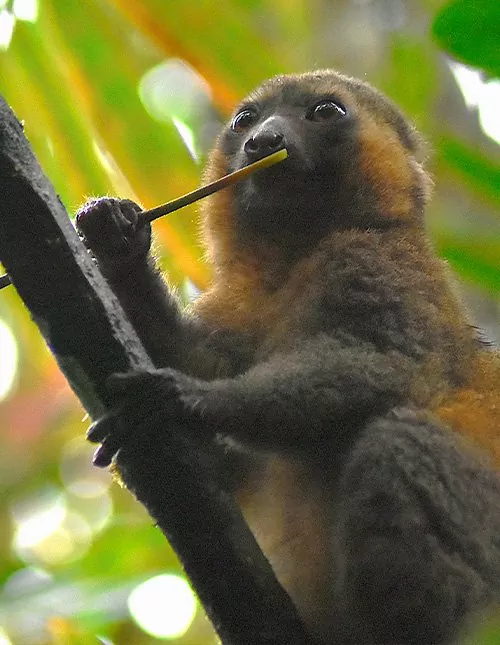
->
[76,197,248,378]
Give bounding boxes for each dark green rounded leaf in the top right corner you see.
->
[432,0,500,76]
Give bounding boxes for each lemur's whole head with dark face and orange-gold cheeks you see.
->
[203,70,426,247]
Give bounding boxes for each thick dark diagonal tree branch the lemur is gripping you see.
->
[0,97,309,645]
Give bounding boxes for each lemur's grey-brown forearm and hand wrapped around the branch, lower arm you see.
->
[89,335,415,465]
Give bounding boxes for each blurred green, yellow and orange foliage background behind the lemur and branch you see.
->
[0,0,500,645]
